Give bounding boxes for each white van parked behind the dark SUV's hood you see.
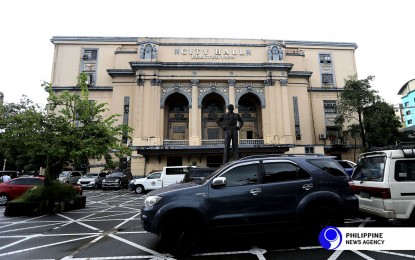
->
[130,166,194,194]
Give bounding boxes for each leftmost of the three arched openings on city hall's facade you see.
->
[164,93,189,140]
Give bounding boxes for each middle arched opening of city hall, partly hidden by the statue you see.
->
[202,93,225,140]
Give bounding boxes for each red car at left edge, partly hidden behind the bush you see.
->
[0,177,82,205]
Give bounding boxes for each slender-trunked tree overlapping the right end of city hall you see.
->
[336,76,380,149]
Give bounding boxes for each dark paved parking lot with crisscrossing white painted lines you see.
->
[0,190,415,260]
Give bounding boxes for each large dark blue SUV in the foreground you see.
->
[141,155,359,253]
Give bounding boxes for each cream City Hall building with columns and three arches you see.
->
[51,36,359,175]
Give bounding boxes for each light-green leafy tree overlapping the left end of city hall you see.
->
[43,73,132,183]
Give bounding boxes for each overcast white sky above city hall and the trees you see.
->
[0,0,415,105]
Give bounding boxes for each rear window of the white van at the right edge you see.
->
[352,156,386,182]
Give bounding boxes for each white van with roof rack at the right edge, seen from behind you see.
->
[351,143,415,224]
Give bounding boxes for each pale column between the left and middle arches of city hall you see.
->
[189,79,202,146]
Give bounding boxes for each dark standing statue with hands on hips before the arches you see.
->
[216,104,244,164]
